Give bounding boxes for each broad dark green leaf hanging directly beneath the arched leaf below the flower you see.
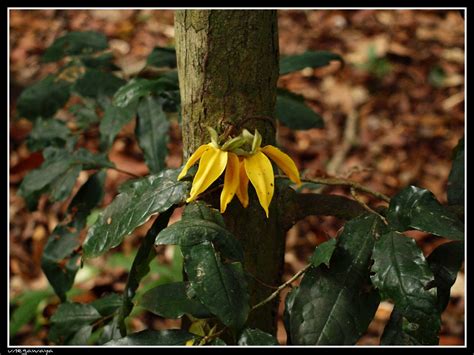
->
[182,241,250,329]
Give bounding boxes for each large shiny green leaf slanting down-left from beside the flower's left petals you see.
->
[83,169,189,257]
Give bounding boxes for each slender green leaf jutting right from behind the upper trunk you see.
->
[280,51,344,75]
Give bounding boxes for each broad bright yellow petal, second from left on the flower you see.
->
[186,147,228,202]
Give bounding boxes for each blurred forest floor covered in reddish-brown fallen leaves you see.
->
[9,10,465,345]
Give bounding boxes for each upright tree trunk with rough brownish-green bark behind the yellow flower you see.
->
[175,10,285,333]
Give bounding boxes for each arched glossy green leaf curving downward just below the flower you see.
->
[155,218,244,261]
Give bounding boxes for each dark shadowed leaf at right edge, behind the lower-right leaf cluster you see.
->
[427,242,464,312]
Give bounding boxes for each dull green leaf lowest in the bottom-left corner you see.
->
[49,303,101,343]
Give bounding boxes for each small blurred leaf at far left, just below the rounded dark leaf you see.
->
[26,118,71,152]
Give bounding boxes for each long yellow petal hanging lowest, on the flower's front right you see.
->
[244,151,274,218]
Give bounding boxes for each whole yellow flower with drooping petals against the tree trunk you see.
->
[178,130,301,218]
